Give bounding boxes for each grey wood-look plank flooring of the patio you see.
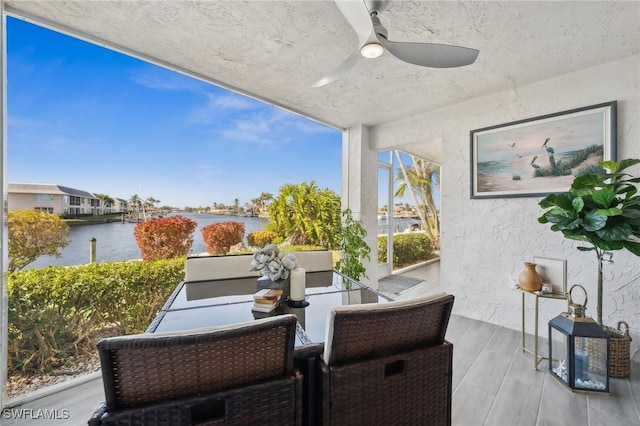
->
[6,265,640,426]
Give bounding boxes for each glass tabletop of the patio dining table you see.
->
[147,271,389,347]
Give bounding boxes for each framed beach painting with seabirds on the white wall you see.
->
[471,101,617,198]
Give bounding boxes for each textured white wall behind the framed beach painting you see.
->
[371,56,640,349]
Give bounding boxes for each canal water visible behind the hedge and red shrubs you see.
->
[25,213,269,269]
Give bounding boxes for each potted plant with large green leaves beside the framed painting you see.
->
[538,159,640,325]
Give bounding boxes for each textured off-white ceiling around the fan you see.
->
[2,0,640,133]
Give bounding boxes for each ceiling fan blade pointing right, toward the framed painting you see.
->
[380,37,480,68]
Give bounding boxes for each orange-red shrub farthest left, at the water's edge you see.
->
[133,215,198,260]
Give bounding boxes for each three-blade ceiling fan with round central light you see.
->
[313,0,479,87]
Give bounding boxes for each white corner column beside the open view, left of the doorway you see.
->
[342,124,378,288]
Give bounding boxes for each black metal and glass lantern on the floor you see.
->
[549,285,609,393]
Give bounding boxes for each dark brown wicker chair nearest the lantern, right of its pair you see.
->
[320,293,454,426]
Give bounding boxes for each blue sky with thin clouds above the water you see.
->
[7,18,341,207]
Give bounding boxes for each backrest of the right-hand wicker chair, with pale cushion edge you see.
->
[323,293,454,365]
